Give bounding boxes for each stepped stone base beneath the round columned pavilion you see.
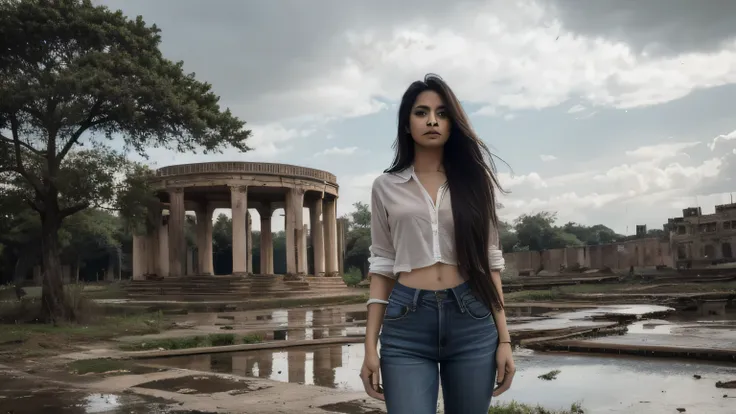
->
[126,275,349,301]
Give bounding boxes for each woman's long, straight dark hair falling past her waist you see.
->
[385,74,503,309]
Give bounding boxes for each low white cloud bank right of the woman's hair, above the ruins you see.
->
[499,131,736,232]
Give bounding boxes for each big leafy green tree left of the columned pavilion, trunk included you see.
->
[0,0,250,322]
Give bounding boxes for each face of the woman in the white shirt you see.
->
[409,91,451,148]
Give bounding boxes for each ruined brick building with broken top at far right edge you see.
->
[664,203,736,268]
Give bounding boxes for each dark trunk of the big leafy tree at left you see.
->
[41,207,67,324]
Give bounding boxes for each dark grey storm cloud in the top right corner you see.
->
[552,0,736,55]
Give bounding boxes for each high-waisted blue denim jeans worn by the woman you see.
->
[380,282,498,414]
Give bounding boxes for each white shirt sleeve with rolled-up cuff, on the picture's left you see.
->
[368,177,396,279]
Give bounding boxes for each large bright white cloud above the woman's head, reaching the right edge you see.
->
[274,2,736,123]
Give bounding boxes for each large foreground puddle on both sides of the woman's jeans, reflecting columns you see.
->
[145,342,736,414]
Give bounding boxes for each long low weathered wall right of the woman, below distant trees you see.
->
[503,238,674,272]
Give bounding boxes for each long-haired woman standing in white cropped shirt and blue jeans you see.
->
[360,75,515,414]
